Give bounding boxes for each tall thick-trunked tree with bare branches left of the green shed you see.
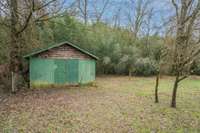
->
[0,0,64,92]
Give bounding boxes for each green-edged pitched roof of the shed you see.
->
[24,41,99,60]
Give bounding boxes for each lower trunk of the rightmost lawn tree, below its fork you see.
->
[171,75,179,108]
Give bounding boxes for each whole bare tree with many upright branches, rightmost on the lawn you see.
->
[171,0,200,108]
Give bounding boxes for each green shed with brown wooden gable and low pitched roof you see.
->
[24,42,98,86]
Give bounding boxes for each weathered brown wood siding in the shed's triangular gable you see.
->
[37,45,93,59]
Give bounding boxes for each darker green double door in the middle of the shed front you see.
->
[54,59,78,84]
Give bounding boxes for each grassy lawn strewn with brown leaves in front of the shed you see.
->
[0,76,200,133]
